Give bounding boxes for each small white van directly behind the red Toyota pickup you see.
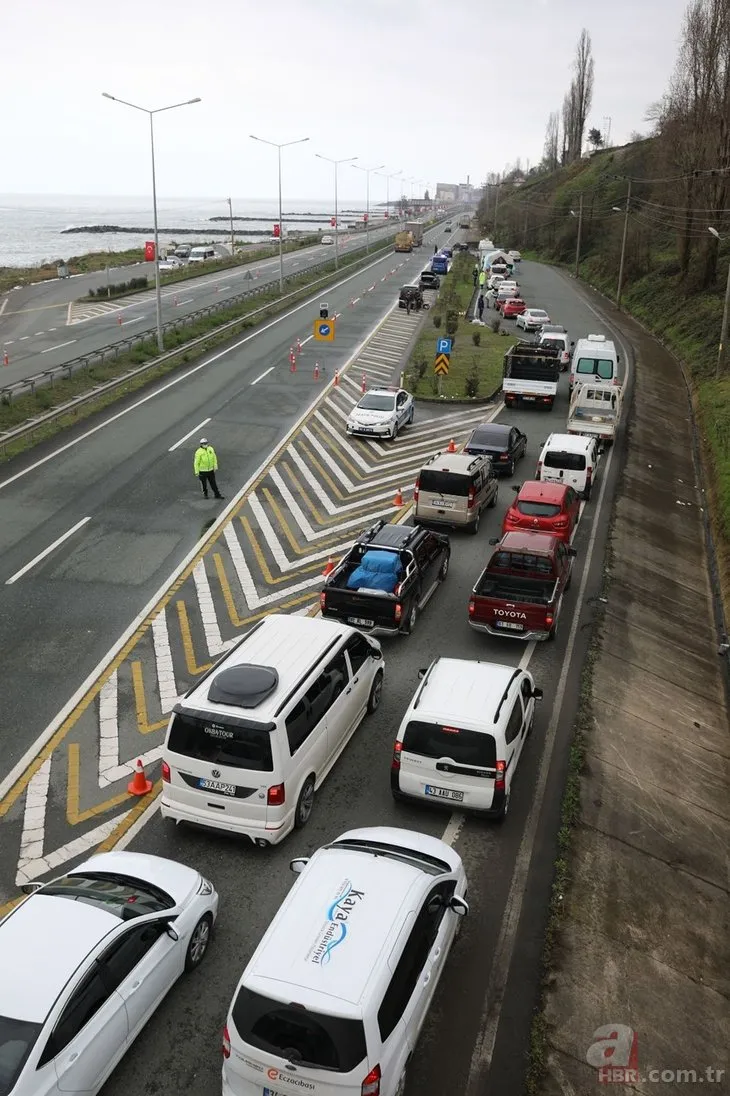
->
[390,658,543,820]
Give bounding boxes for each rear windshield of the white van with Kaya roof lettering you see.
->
[232,986,367,1073]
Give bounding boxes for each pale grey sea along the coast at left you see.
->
[0,194,364,266]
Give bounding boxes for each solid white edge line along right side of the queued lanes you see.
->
[466,313,630,1096]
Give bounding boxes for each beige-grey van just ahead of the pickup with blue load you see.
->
[413,453,499,534]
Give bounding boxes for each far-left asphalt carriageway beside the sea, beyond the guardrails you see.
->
[0,218,403,387]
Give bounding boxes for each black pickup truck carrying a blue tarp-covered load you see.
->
[319,521,450,635]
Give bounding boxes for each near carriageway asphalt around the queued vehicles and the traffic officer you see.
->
[0,252,630,1096]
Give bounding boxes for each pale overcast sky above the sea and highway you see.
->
[0,0,686,201]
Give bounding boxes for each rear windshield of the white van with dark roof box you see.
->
[168,713,274,773]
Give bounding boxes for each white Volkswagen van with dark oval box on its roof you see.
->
[160,614,384,846]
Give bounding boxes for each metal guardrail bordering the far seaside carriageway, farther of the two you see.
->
[0,235,403,407]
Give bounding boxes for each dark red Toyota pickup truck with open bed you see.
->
[469,532,575,640]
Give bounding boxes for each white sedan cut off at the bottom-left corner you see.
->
[0,853,218,1096]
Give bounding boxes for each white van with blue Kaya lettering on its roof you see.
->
[223,826,468,1096]
